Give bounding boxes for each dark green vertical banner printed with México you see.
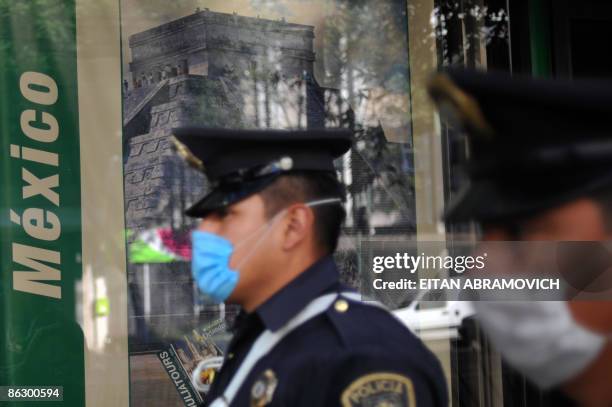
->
[0,0,85,407]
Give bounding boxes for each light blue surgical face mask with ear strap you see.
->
[191,198,341,303]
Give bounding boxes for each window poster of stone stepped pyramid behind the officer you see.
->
[121,0,415,405]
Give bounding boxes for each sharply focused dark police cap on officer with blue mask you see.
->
[173,127,352,217]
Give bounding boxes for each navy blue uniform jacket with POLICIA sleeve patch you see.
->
[204,256,448,407]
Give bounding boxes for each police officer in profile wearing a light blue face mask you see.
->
[174,127,447,407]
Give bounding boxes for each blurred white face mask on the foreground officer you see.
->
[473,301,606,389]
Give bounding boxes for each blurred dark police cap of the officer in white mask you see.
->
[429,70,612,222]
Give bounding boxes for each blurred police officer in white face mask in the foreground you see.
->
[429,71,612,406]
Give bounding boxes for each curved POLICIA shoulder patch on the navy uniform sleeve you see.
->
[341,372,416,407]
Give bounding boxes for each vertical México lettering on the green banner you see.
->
[9,72,62,299]
